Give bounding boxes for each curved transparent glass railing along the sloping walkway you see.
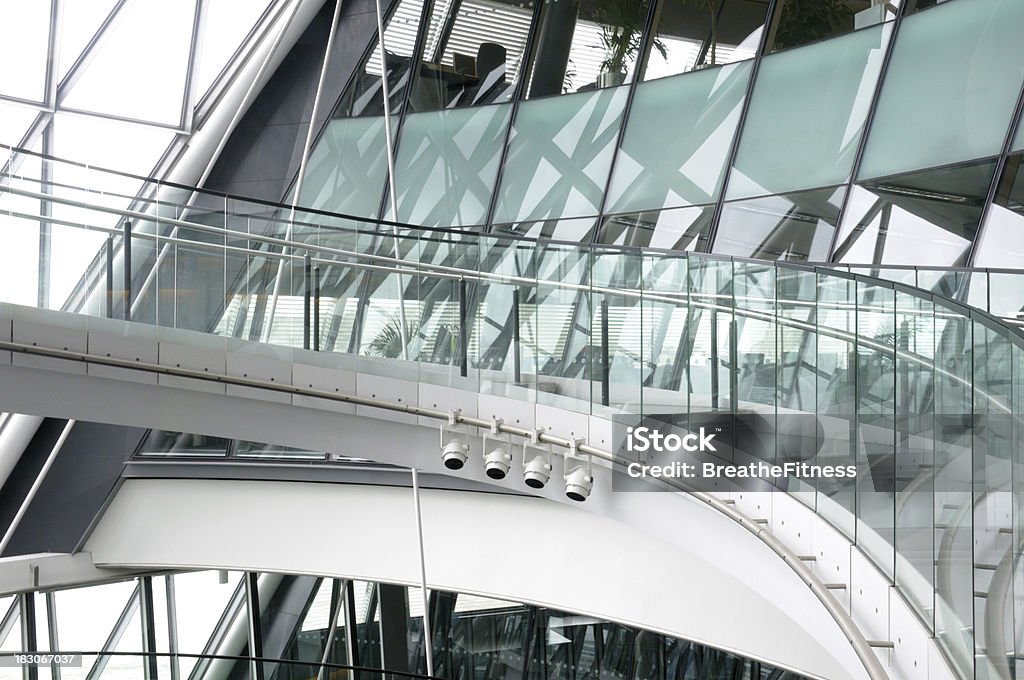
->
[0,140,1024,677]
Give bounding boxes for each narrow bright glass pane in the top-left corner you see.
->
[0,2,50,102]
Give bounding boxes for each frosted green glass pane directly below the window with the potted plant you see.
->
[494,87,627,222]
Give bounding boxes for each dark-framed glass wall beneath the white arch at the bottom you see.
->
[0,570,803,680]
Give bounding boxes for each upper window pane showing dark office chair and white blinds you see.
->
[410,0,534,111]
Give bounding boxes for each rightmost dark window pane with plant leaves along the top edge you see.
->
[768,0,900,52]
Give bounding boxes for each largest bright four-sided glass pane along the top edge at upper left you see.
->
[61,0,196,125]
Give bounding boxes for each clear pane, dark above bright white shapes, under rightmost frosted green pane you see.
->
[833,161,995,266]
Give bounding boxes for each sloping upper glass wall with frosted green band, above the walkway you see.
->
[280,0,1024,278]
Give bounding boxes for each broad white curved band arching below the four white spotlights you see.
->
[86,479,863,680]
